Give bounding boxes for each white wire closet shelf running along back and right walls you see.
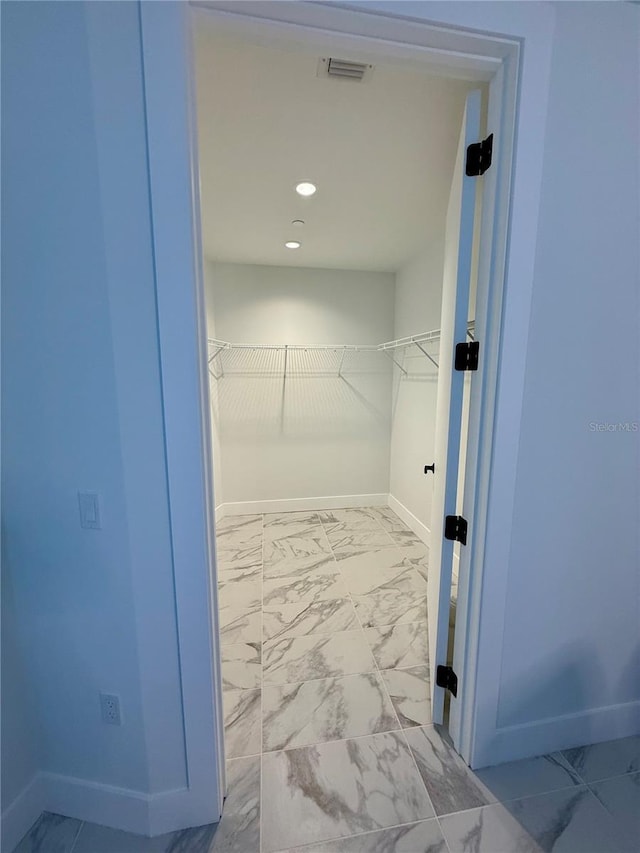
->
[208,322,474,379]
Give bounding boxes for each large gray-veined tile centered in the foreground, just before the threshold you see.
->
[262,733,433,853]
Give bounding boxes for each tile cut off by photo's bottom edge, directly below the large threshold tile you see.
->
[284,818,448,853]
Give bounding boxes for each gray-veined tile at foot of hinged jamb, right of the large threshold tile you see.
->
[405,726,496,816]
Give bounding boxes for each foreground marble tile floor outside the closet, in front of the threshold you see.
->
[14,726,640,853]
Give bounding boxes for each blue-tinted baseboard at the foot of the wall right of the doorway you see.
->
[472,702,640,769]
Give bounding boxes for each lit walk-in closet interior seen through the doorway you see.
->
[196,11,477,820]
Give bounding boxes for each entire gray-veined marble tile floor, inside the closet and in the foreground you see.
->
[15,507,640,853]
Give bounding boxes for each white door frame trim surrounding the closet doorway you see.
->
[139,0,553,825]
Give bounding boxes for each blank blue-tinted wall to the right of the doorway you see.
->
[499,3,640,739]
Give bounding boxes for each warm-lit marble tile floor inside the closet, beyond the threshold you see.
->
[218,507,431,759]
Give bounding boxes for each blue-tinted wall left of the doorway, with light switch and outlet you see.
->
[2,2,191,849]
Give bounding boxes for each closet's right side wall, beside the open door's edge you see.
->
[390,243,446,528]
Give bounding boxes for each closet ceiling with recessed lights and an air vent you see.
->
[196,18,471,271]
